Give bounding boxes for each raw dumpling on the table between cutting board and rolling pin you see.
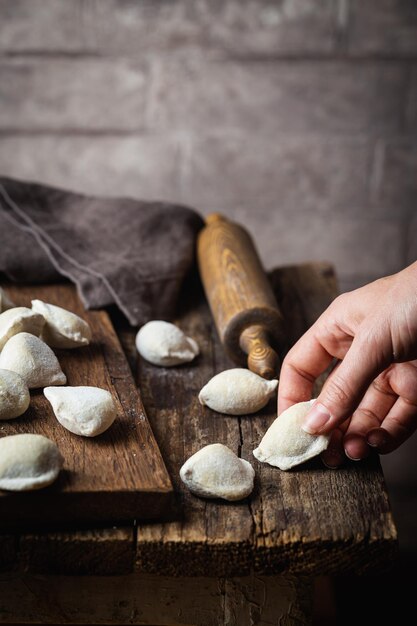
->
[136,320,200,367]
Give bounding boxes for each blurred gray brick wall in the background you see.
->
[0,0,417,289]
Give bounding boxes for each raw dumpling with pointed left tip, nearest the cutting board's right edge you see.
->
[43,386,117,437]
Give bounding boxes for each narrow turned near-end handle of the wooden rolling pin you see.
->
[239,326,279,380]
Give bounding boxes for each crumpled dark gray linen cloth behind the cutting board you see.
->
[0,177,203,325]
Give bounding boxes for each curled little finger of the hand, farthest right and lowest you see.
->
[367,398,417,454]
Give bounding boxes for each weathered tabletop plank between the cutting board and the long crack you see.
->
[138,284,253,576]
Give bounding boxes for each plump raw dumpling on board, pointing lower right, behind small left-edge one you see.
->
[0,333,67,389]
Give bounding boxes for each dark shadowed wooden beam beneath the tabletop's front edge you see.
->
[0,574,311,626]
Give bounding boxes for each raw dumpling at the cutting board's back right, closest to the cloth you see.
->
[32,300,91,348]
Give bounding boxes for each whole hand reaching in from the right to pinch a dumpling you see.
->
[278,263,417,467]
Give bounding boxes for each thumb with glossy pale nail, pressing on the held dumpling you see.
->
[302,333,389,435]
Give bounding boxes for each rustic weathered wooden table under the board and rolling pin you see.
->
[0,264,397,626]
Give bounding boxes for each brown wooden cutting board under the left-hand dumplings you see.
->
[0,284,173,528]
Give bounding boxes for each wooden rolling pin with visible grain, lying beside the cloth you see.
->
[197,213,283,379]
